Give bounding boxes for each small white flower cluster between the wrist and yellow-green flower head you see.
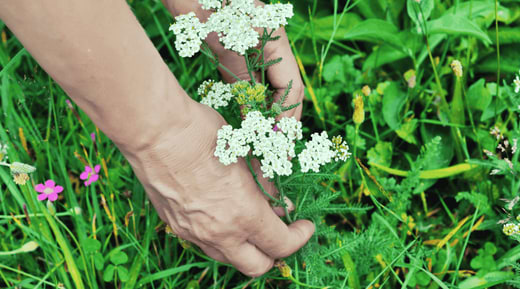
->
[197,80,233,109]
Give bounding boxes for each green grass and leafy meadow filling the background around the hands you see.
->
[0,0,520,289]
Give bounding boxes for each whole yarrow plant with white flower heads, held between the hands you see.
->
[170,0,356,276]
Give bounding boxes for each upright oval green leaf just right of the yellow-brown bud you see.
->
[383,82,406,130]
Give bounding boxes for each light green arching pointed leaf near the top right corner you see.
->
[427,14,492,44]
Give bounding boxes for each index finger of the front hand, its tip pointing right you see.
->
[248,201,314,259]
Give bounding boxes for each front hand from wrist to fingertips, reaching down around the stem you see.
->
[126,100,314,277]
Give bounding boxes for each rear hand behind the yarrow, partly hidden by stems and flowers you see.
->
[163,0,305,120]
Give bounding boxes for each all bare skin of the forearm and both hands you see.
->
[0,0,314,276]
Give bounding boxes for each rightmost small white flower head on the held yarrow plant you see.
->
[298,131,336,173]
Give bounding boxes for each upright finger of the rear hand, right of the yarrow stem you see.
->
[265,28,304,120]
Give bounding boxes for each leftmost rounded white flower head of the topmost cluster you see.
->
[170,12,209,57]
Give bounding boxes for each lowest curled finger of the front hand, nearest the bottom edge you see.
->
[220,242,274,277]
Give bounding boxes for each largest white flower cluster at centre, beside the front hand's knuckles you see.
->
[215,111,302,178]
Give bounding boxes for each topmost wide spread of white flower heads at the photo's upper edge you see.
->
[170,0,293,57]
